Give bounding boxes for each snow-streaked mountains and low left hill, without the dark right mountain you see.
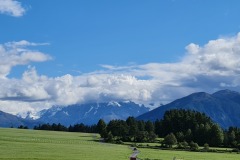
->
[0,101,149,128]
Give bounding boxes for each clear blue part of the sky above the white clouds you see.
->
[0,0,240,77]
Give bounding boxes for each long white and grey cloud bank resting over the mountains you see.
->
[0,33,240,114]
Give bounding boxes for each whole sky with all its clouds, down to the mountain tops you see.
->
[0,0,240,115]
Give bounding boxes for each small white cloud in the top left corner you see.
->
[0,0,26,17]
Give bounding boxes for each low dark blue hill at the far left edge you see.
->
[0,111,37,128]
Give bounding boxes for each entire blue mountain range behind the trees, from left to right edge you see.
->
[0,90,240,128]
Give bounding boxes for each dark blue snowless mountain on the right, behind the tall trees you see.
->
[137,90,240,128]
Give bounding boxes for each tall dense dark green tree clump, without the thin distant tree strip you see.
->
[97,109,224,146]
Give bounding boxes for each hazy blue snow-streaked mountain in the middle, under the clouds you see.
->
[37,102,149,126]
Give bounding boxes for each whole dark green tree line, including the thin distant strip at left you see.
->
[27,109,240,149]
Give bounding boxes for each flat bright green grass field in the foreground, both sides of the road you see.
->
[0,128,240,160]
